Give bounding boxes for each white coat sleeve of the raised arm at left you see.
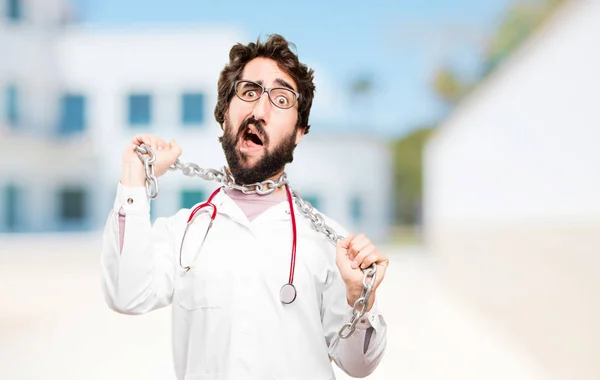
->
[101,184,180,314]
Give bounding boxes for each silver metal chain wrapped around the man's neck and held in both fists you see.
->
[135,144,377,339]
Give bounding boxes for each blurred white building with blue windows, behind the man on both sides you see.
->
[0,0,392,240]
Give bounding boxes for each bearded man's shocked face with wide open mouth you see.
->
[221,58,304,184]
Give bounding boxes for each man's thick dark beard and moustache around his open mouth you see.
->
[219,118,298,185]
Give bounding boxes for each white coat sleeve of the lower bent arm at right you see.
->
[321,267,387,377]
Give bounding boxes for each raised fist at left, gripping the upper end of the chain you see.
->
[121,134,181,187]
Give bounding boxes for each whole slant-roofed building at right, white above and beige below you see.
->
[424,0,600,380]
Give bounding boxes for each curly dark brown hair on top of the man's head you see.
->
[215,34,315,134]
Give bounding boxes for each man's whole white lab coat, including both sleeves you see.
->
[101,185,386,380]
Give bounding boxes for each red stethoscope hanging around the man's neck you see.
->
[179,186,296,305]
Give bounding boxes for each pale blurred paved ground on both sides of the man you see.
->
[0,235,549,380]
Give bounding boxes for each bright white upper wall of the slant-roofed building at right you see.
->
[425,1,600,223]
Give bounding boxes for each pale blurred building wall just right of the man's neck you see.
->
[287,131,393,240]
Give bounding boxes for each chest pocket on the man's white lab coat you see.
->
[174,266,226,312]
